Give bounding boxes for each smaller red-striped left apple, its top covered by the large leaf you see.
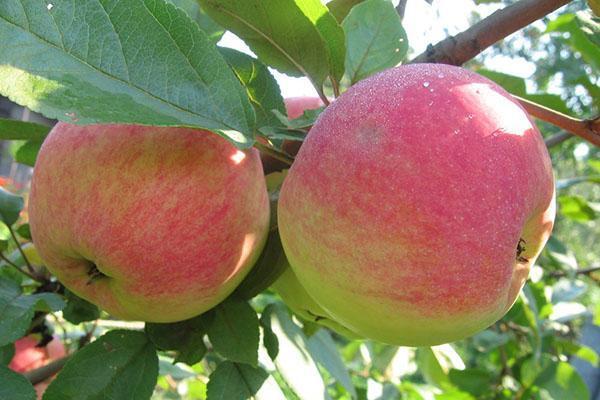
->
[29,123,269,322]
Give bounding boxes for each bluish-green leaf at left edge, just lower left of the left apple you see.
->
[0,277,64,346]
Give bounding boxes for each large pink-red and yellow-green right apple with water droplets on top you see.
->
[278,64,555,346]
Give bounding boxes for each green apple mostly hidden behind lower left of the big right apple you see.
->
[271,262,359,339]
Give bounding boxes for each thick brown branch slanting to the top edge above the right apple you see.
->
[411,0,571,65]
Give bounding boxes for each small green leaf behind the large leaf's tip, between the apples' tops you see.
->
[219,47,285,128]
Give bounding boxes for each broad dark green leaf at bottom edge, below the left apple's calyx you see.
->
[44,330,158,400]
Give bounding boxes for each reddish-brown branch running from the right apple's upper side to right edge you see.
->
[514,96,600,146]
